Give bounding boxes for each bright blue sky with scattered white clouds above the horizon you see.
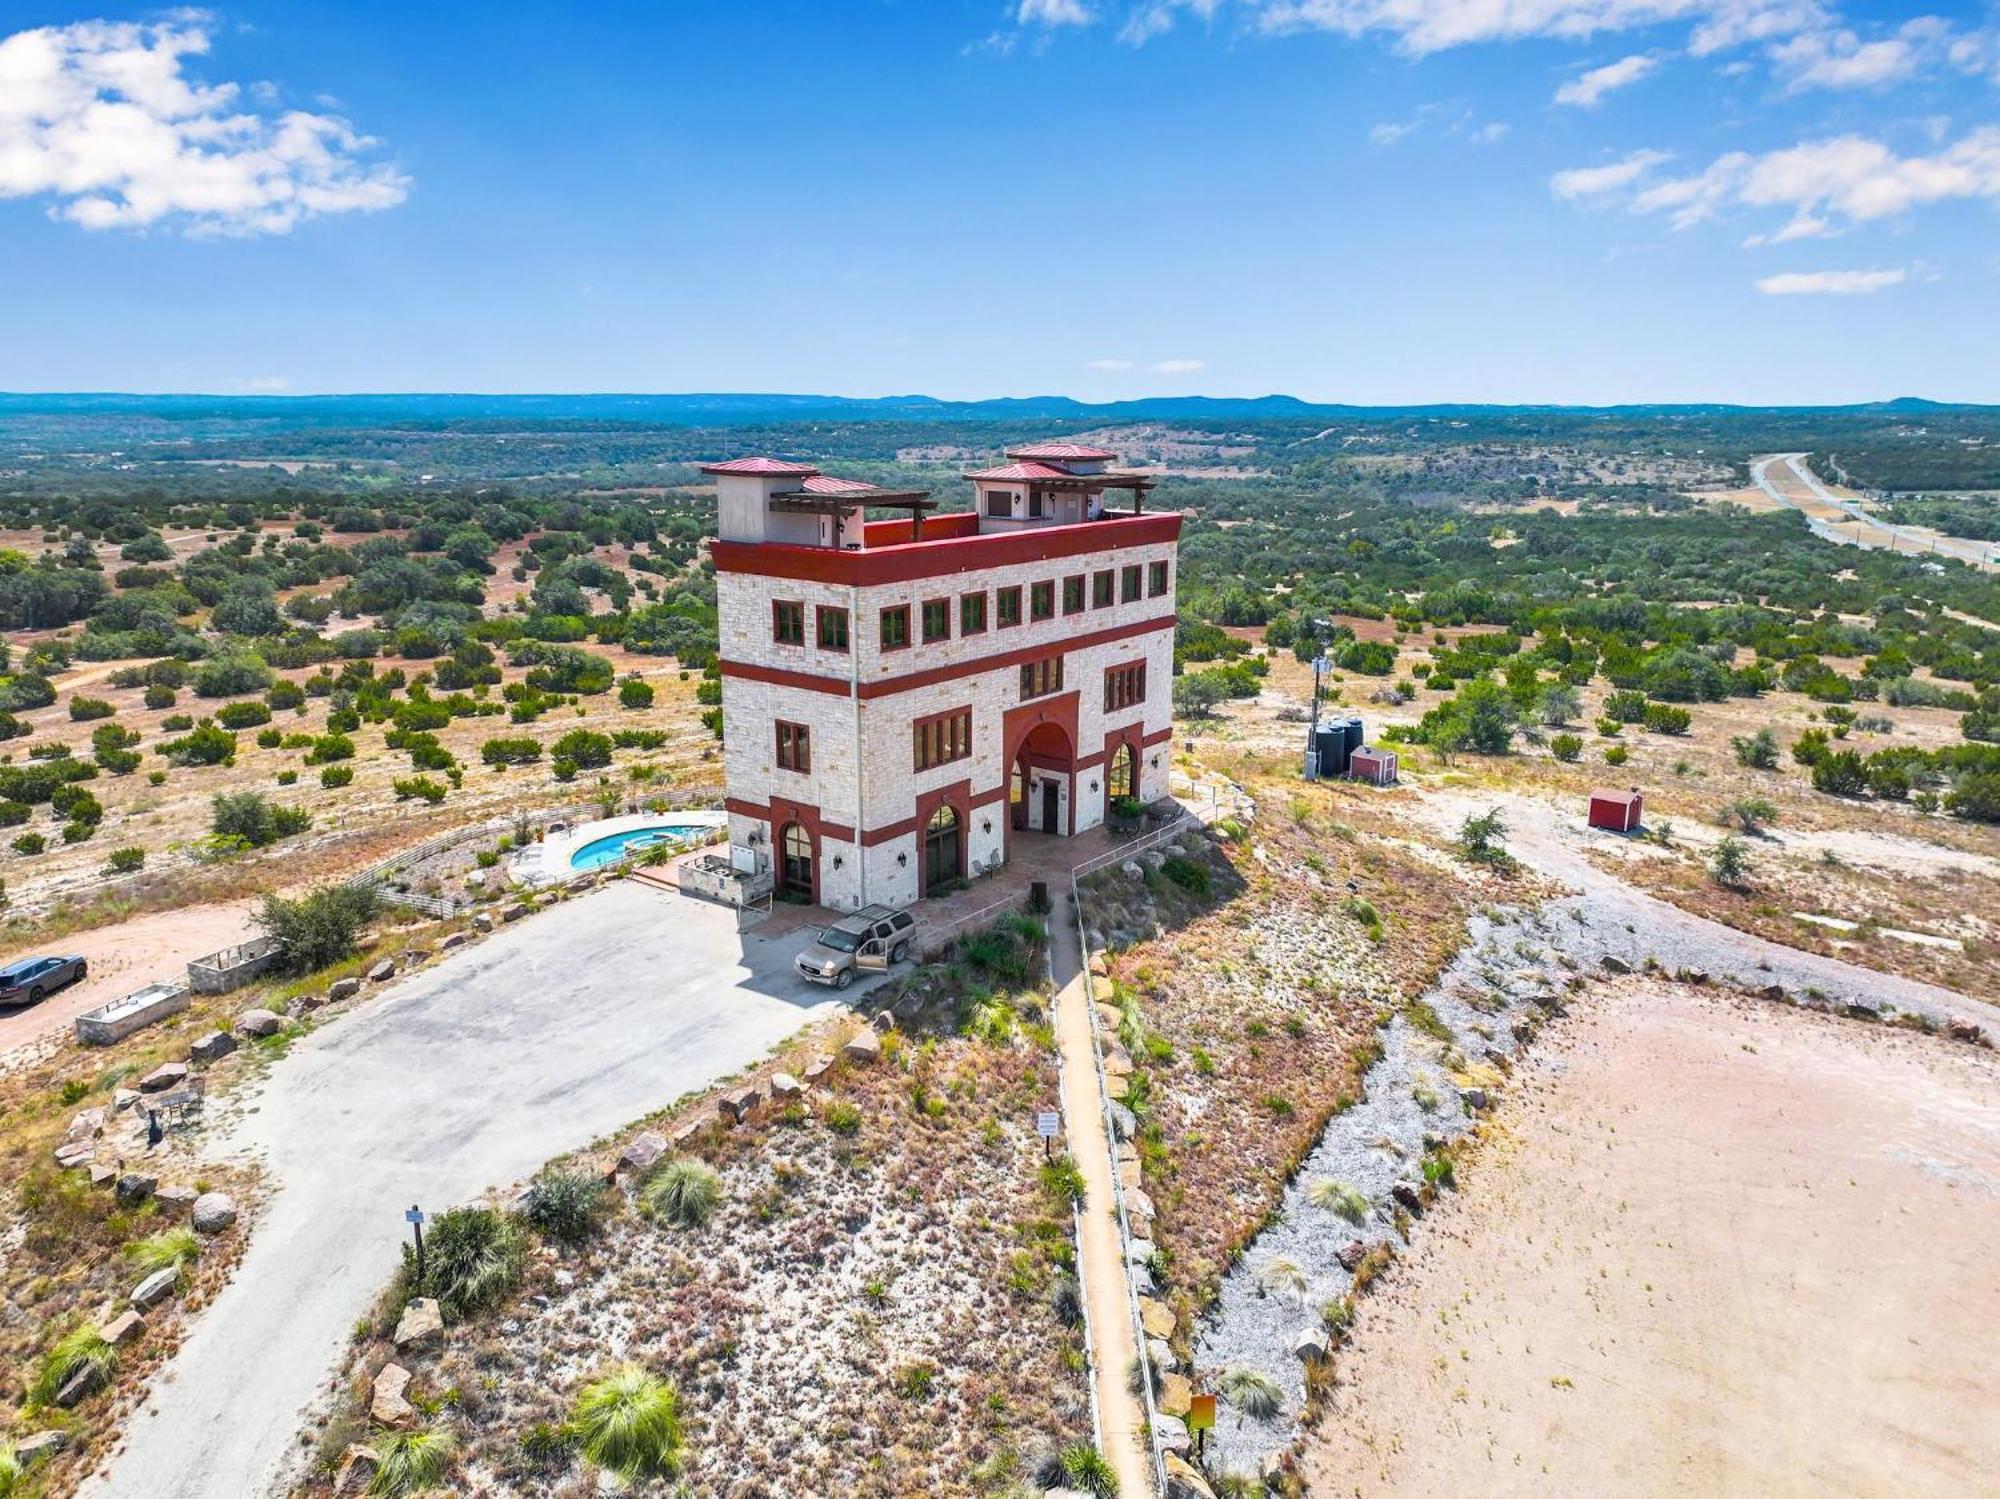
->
[0,0,2000,404]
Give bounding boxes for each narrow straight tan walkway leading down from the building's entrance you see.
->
[1048,891,1154,1499]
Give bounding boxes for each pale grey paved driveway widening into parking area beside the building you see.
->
[84,881,864,1499]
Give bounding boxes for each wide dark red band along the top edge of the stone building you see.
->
[708,510,1180,588]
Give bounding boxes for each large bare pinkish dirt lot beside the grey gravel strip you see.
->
[1306,983,2000,1497]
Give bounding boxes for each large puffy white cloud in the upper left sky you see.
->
[0,12,410,234]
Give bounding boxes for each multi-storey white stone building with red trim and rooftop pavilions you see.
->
[702,442,1180,909]
